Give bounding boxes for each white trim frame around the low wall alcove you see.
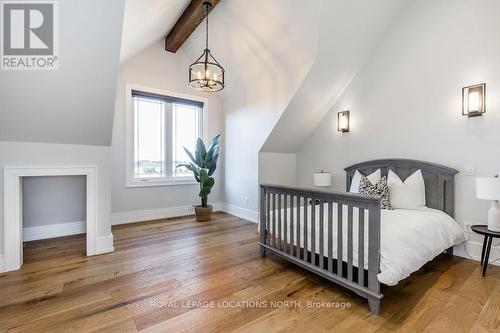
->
[3,166,113,271]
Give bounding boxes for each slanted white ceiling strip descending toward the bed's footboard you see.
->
[261,0,410,153]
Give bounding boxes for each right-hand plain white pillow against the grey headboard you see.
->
[387,170,425,209]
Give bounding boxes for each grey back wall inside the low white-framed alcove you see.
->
[22,176,87,228]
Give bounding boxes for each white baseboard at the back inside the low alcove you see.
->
[23,221,87,242]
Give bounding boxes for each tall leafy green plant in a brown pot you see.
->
[177,134,220,221]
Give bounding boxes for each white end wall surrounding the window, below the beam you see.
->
[112,41,225,214]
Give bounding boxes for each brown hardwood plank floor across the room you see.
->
[0,213,500,333]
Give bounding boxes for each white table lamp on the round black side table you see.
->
[476,175,500,232]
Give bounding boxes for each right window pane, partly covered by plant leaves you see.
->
[172,103,201,177]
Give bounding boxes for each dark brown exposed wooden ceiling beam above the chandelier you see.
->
[165,0,220,53]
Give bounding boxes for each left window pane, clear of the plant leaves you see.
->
[134,98,165,178]
